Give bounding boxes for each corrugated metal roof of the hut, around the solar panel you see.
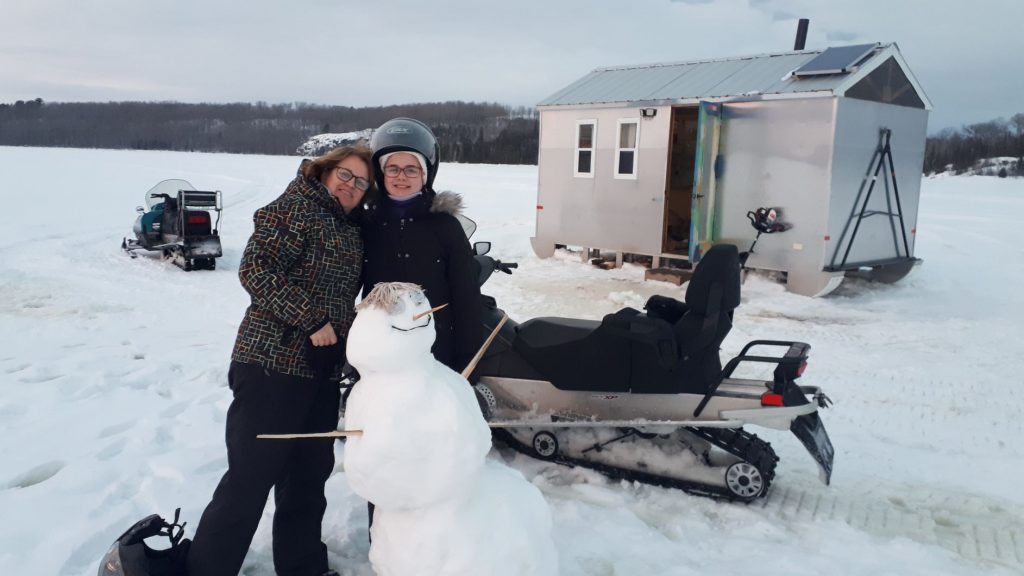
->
[538,44,891,106]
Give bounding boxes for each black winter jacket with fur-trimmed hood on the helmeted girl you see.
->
[362,191,483,372]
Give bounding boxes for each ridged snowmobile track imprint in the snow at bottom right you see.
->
[751,485,1024,568]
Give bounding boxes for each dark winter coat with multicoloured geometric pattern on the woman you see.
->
[231,161,362,378]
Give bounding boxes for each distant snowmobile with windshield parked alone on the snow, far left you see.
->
[121,179,223,272]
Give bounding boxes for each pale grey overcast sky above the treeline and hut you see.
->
[0,0,1024,131]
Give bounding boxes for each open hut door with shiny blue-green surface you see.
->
[689,101,722,263]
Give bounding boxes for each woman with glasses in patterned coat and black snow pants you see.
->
[187,147,373,576]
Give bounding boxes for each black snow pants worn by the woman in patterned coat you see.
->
[188,362,341,576]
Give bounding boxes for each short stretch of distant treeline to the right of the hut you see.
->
[925,113,1024,177]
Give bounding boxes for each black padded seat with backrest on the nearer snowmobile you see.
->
[513,245,739,394]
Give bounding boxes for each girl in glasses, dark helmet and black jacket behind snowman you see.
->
[362,118,483,372]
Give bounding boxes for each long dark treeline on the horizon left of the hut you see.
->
[0,98,538,164]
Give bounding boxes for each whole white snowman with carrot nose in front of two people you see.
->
[345,283,558,576]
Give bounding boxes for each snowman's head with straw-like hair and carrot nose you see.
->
[346,282,435,374]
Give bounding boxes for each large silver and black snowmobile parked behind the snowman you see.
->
[474,237,834,501]
